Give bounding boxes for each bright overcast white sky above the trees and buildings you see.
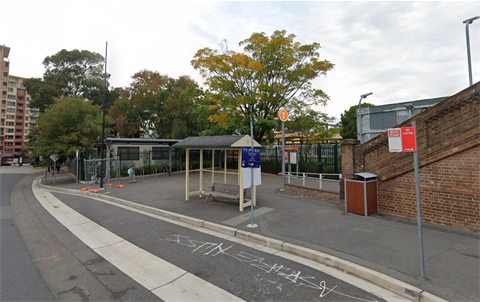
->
[0,0,480,118]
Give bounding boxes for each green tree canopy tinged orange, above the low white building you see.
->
[109,70,203,138]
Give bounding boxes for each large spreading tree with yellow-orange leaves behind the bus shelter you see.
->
[191,30,334,142]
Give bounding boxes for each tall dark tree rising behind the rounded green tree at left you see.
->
[23,49,111,112]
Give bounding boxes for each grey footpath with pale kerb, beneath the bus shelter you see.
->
[37,171,480,302]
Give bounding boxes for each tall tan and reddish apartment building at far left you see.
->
[0,45,38,161]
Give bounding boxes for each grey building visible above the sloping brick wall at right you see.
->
[357,97,448,143]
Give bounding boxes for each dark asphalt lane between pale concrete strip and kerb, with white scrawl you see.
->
[53,193,390,301]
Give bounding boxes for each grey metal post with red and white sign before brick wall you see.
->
[388,121,425,279]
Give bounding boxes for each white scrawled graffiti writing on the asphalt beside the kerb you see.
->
[165,234,377,302]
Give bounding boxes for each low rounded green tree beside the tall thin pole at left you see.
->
[31,97,112,158]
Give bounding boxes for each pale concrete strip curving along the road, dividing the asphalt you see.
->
[32,182,243,301]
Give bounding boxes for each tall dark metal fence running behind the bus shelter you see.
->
[69,143,342,182]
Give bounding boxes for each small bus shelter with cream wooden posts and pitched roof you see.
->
[172,135,261,211]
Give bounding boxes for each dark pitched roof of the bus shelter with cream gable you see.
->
[172,135,261,149]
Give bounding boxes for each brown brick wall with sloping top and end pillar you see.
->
[342,82,480,232]
